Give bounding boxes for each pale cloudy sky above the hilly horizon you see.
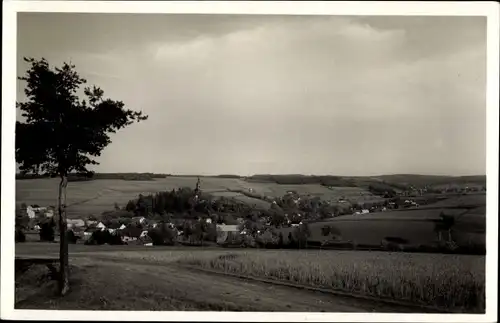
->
[17,13,486,176]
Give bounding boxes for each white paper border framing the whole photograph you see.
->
[0,1,499,322]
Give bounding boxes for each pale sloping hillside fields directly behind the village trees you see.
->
[16,176,377,218]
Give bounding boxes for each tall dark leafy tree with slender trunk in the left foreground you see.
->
[16,58,147,295]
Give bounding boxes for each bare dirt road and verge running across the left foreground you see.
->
[16,244,422,313]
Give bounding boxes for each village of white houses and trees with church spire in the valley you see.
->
[16,178,474,246]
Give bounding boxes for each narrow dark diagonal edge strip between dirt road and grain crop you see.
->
[173,263,464,313]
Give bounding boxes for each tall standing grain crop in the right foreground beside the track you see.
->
[179,251,485,312]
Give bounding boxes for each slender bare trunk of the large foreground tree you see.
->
[58,175,69,296]
